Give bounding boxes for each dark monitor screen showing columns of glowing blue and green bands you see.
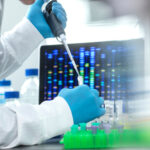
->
[39,39,144,103]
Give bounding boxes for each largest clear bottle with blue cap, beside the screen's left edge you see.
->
[20,69,39,104]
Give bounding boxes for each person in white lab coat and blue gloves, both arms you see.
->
[0,0,105,149]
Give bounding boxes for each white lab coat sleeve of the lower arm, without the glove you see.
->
[0,97,73,149]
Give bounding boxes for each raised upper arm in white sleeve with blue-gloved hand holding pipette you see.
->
[0,0,67,79]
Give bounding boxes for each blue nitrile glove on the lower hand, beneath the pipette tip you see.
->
[58,85,105,124]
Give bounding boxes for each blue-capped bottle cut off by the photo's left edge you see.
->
[0,80,13,106]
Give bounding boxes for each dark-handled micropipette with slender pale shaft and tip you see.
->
[42,0,83,85]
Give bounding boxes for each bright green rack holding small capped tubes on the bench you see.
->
[60,123,150,149]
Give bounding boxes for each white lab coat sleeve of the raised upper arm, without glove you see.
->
[0,18,44,79]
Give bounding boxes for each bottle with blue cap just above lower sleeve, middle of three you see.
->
[5,91,20,105]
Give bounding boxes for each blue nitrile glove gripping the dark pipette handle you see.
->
[27,0,67,38]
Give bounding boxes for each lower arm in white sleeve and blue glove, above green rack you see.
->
[0,85,105,149]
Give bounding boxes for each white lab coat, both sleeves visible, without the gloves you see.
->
[0,18,73,149]
